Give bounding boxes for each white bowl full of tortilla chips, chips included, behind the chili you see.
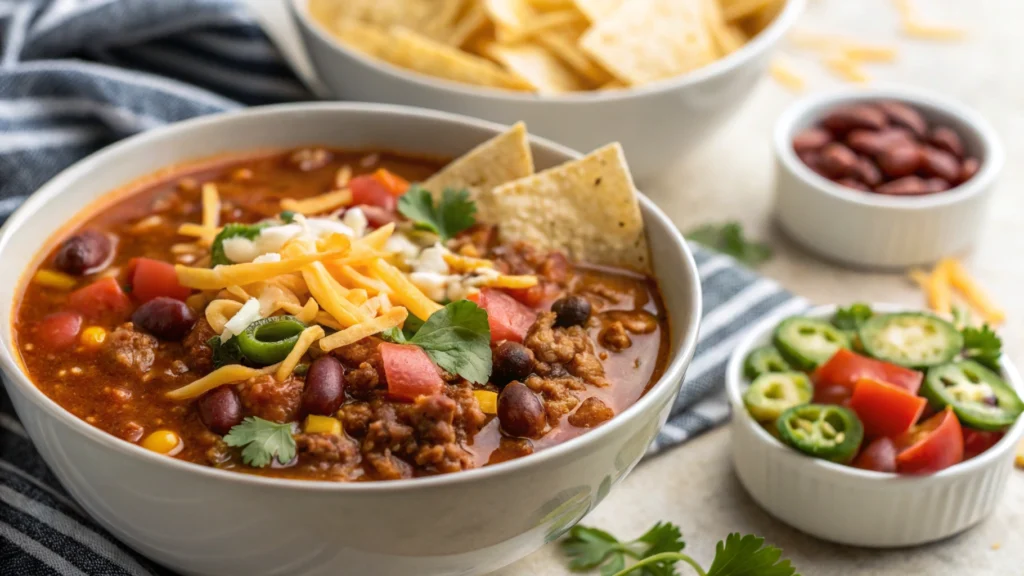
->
[289,0,806,178]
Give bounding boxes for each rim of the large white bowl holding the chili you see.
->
[0,102,701,493]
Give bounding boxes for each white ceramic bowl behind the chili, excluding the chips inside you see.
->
[288,0,806,180]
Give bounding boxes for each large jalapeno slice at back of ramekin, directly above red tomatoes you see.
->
[858,312,964,369]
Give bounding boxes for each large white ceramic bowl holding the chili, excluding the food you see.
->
[0,104,700,576]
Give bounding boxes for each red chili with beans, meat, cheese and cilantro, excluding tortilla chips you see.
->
[15,148,669,481]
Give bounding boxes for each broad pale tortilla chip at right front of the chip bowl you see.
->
[580,0,716,85]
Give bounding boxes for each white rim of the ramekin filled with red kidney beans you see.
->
[772,84,1006,211]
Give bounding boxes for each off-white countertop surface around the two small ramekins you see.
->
[249,0,1024,576]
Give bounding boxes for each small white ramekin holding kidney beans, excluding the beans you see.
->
[774,88,1004,269]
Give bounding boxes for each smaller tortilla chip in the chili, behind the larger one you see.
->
[421,122,534,220]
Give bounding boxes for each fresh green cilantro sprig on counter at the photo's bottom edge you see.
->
[562,522,799,576]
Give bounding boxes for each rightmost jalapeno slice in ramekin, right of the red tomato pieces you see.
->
[921,360,1024,430]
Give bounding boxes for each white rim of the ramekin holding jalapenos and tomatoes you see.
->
[725,302,1024,484]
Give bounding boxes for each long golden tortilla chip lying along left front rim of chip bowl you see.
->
[334,23,530,90]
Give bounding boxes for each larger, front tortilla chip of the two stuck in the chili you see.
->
[488,143,651,275]
